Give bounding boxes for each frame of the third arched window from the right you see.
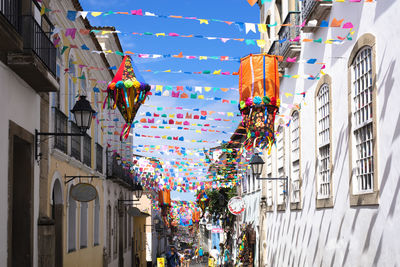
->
[289,107,302,210]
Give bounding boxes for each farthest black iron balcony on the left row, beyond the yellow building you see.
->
[106,152,133,190]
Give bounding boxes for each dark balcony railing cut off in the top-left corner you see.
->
[0,0,23,51]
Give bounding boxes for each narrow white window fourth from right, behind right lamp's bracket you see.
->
[276,125,286,209]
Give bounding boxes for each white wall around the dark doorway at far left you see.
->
[0,62,40,266]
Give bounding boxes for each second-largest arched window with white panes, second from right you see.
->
[315,75,333,208]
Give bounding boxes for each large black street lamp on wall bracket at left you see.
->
[35,95,95,160]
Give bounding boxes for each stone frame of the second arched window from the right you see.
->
[314,74,334,209]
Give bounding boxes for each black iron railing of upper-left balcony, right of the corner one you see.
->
[21,16,57,77]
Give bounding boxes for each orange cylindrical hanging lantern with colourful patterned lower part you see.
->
[239,54,280,152]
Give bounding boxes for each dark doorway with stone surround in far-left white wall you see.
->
[8,121,34,267]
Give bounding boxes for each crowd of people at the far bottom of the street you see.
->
[166,245,233,267]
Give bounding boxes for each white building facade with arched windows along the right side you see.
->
[259,0,400,266]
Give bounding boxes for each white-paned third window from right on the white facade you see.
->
[290,110,300,203]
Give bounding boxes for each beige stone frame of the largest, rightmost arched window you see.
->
[347,33,379,206]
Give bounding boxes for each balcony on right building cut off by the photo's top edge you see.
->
[301,0,332,33]
